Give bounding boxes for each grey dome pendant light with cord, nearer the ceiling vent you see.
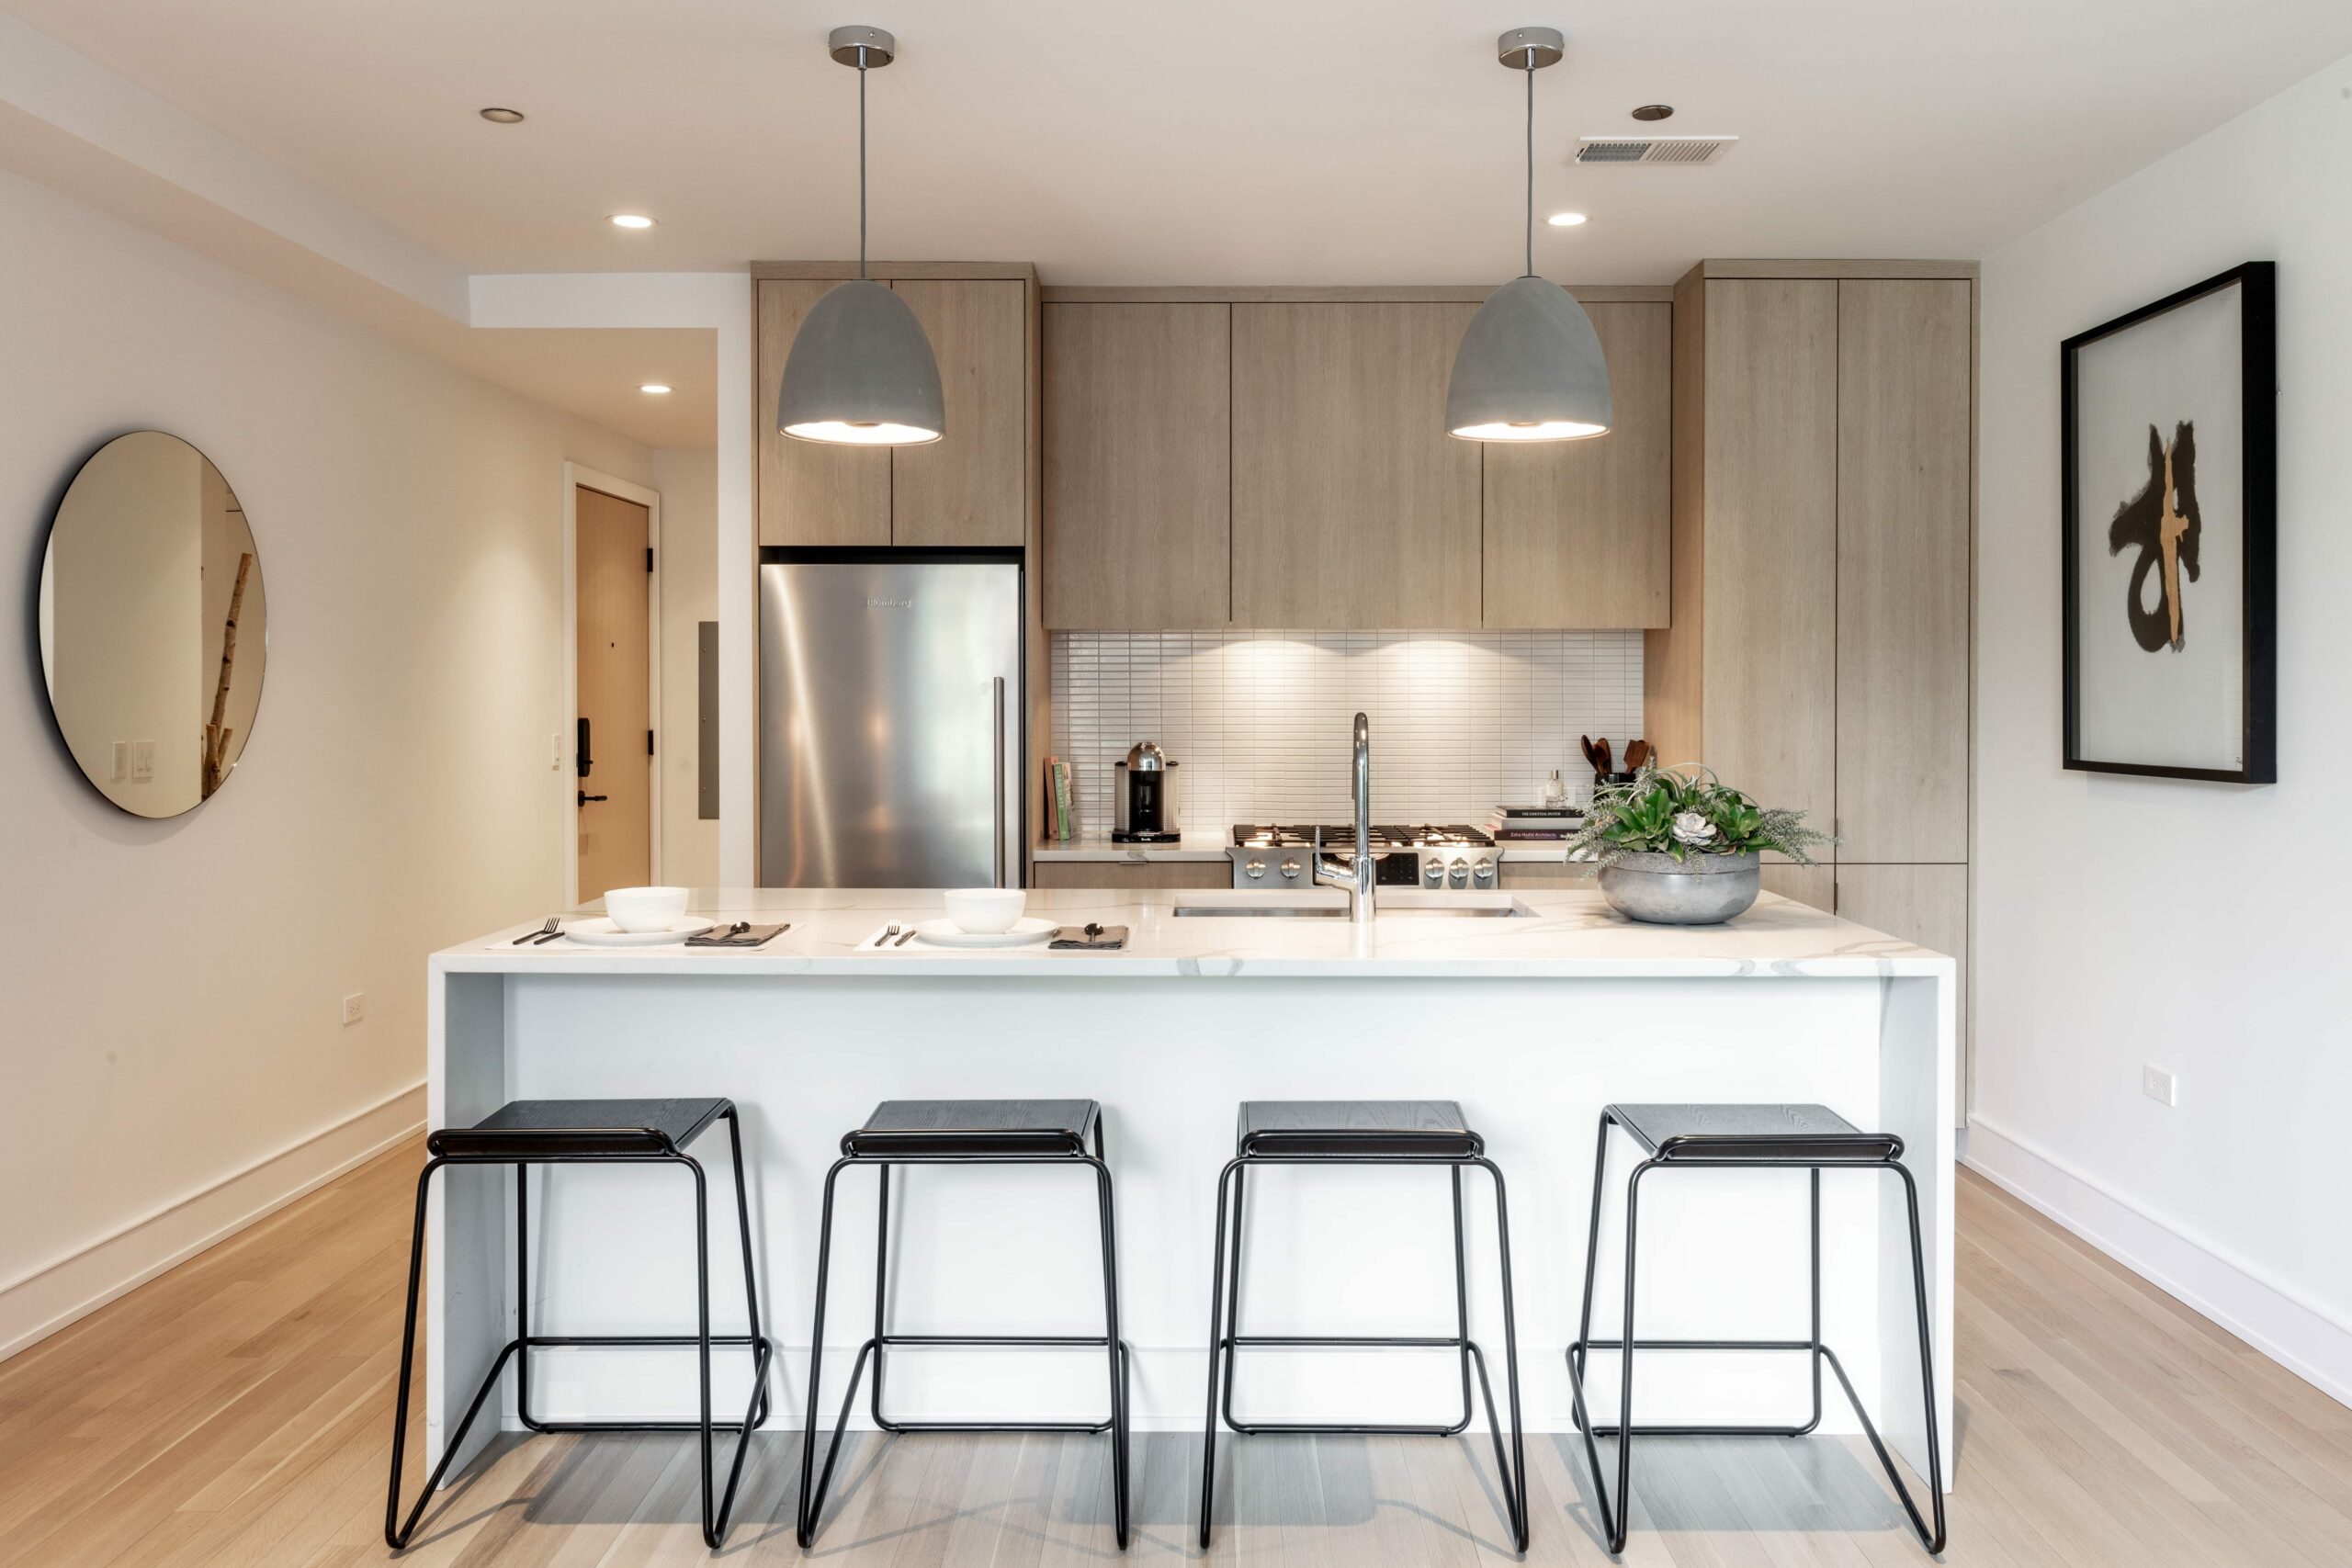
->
[1446,28,1611,442]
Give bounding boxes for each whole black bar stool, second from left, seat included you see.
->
[799,1100,1129,1551]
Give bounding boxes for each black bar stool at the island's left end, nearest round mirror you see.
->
[383,1100,774,1551]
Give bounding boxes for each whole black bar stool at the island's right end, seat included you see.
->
[1569,1105,1945,1554]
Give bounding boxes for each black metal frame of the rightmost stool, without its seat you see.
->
[1569,1110,1945,1556]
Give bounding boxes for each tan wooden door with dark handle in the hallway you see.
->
[574,484,654,903]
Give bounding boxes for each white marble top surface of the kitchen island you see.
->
[430,888,1954,980]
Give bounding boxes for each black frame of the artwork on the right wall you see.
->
[2058,261,2279,785]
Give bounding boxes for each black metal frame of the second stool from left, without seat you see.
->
[797,1114,1131,1551]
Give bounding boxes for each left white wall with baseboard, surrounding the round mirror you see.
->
[0,174,654,1354]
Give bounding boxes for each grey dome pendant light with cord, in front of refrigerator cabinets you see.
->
[776,28,948,446]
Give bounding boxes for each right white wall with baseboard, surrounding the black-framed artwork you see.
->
[1969,62,2352,1401]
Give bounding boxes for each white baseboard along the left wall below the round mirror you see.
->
[0,1084,425,1361]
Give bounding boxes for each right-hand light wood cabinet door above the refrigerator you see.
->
[891,277,1028,546]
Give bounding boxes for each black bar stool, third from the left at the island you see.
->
[1200,1100,1526,1551]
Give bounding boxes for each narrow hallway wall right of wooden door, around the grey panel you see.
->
[654,449,719,886]
